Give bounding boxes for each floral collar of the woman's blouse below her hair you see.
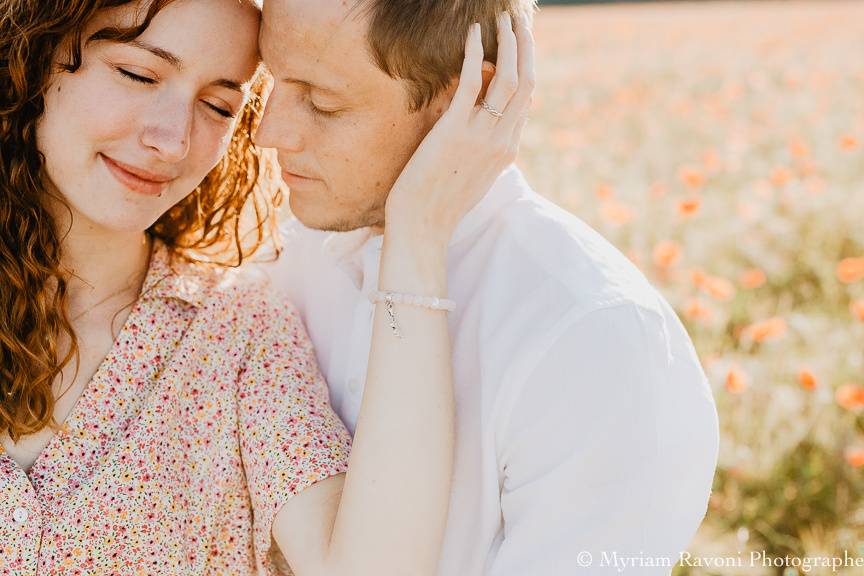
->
[140,239,224,308]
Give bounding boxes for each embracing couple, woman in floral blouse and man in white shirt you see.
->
[0,0,718,576]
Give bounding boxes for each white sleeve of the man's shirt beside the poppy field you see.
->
[487,303,719,576]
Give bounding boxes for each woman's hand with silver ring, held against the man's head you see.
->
[385,12,534,250]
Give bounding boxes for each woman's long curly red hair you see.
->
[0,0,282,441]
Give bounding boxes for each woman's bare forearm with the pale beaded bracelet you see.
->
[328,235,454,576]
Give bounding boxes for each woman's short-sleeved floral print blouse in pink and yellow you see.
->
[0,242,350,576]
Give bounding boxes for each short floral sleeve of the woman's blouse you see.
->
[238,290,351,574]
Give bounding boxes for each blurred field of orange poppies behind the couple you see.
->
[520,0,864,575]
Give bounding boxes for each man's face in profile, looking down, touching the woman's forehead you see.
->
[255,0,443,231]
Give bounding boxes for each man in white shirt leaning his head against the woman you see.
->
[256,0,718,576]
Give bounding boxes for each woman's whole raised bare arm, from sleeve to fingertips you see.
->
[273,15,533,576]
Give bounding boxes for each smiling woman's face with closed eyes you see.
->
[37,0,259,232]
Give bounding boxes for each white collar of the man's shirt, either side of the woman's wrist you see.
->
[323,165,530,296]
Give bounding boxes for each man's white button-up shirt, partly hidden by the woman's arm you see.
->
[265,167,719,576]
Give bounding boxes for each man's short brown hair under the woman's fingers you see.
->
[357,0,536,110]
